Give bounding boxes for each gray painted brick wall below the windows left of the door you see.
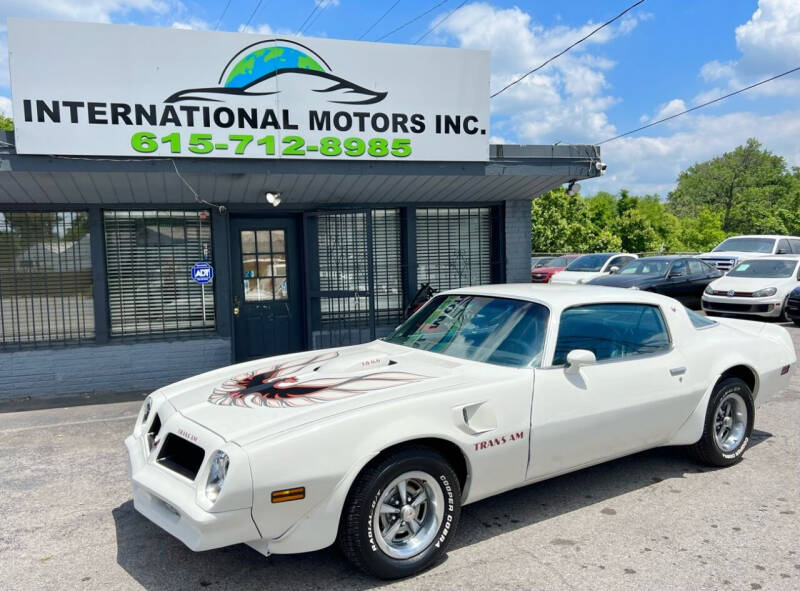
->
[0,337,231,400]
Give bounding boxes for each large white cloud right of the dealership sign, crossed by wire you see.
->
[432,3,648,143]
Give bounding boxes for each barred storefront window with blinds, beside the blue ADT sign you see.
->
[104,211,215,337]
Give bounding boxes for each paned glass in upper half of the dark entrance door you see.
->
[240,230,289,302]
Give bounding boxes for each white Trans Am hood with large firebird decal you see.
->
[159,341,482,445]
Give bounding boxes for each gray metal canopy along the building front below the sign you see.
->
[0,134,600,208]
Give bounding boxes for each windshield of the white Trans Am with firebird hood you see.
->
[384,295,550,367]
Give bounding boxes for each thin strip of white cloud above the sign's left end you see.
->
[0,0,169,23]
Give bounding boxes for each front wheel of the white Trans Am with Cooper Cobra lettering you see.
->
[338,447,461,579]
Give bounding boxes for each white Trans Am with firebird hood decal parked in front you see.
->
[125,284,796,578]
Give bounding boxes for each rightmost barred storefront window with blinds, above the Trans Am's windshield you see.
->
[417,207,492,291]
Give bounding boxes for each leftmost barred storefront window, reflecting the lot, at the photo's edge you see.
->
[0,211,94,348]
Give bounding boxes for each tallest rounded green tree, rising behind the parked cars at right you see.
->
[669,138,794,232]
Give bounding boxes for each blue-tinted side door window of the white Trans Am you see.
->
[553,304,670,365]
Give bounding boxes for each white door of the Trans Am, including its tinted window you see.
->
[527,303,696,479]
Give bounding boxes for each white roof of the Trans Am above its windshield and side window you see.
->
[437,283,676,311]
